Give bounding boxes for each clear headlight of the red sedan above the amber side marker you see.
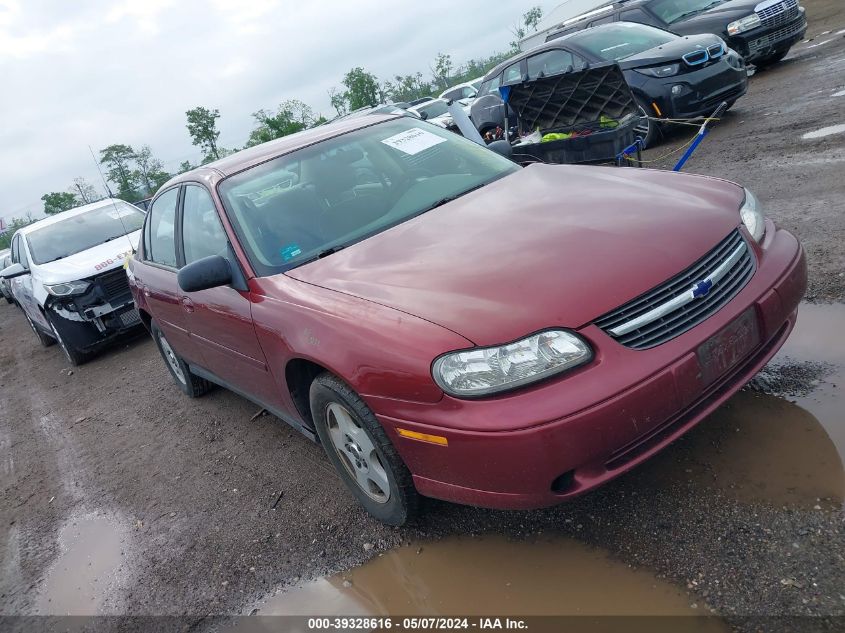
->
[432,330,593,398]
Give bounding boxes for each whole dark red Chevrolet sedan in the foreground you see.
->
[129,116,806,524]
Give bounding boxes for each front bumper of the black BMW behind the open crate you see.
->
[642,60,748,119]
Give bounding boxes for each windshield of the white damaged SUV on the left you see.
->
[26,201,144,264]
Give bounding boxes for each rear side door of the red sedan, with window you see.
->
[133,186,199,363]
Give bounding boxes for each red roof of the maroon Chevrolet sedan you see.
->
[159,114,404,191]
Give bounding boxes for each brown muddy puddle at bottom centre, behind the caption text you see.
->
[259,536,727,631]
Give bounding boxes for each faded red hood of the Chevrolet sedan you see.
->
[286,164,743,345]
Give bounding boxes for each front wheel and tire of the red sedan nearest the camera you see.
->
[310,372,420,525]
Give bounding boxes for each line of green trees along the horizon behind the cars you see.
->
[0,6,543,249]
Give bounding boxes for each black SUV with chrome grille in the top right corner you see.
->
[546,0,807,66]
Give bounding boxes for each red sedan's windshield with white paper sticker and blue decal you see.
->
[219,117,520,276]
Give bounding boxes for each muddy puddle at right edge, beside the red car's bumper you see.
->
[634,304,845,509]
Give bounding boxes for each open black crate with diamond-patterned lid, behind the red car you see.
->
[508,63,640,163]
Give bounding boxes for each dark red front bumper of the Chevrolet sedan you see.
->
[367,223,807,509]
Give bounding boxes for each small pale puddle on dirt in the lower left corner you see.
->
[35,515,122,615]
